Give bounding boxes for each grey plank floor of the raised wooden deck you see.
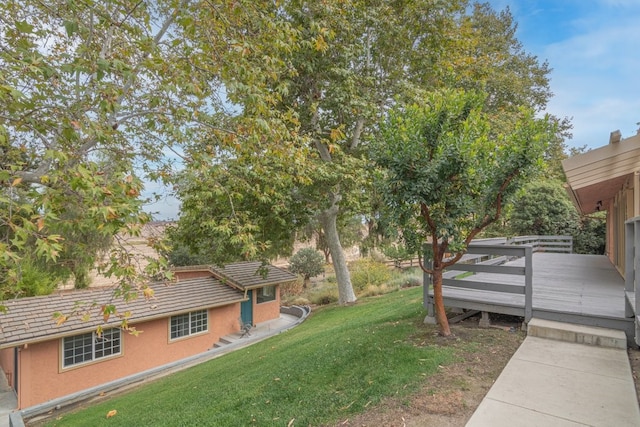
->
[429,252,634,338]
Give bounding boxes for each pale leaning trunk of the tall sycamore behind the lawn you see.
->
[319,194,357,304]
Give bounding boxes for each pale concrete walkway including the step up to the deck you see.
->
[467,319,640,427]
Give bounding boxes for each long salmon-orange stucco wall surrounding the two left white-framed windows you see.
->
[10,303,240,408]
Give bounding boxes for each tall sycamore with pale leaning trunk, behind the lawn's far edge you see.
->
[174,0,550,303]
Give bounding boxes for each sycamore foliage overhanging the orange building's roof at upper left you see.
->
[0,0,296,314]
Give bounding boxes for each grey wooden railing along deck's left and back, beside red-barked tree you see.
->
[424,236,573,323]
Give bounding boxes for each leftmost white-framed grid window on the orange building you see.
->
[62,328,122,368]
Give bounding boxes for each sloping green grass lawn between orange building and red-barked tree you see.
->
[49,287,453,426]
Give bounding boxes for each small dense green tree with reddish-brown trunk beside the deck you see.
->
[371,91,555,336]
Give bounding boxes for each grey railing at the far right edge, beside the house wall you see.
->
[624,216,640,345]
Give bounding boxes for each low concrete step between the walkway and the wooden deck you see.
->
[527,318,627,349]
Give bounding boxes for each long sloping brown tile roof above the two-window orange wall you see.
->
[0,277,244,348]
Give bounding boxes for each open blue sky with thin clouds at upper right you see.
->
[489,0,640,148]
